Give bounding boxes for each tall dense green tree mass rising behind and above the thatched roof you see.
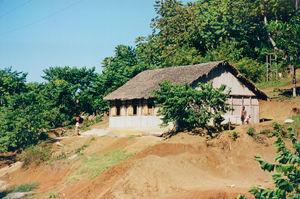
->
[136,0,300,82]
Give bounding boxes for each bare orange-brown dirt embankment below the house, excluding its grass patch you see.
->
[2,129,275,199]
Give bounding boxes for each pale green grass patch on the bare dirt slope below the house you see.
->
[67,149,133,183]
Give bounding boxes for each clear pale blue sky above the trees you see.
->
[0,0,155,82]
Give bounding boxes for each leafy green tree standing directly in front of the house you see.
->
[152,81,230,131]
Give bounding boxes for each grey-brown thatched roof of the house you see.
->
[104,61,268,100]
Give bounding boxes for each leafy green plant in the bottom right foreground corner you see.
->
[238,132,300,199]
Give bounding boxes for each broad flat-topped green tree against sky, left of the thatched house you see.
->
[43,66,99,115]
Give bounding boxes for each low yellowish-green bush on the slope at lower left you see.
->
[17,142,51,168]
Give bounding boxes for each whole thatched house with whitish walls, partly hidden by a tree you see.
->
[104,61,268,129]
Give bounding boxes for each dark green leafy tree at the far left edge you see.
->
[0,83,49,152]
